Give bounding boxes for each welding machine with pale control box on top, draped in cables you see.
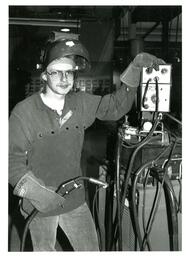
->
[106,64,182,251]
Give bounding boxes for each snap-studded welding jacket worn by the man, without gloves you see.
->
[9,85,136,216]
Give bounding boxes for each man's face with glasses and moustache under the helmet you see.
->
[46,58,74,95]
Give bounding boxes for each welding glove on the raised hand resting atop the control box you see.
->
[120,52,165,87]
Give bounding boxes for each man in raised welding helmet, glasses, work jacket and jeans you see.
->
[9,39,163,251]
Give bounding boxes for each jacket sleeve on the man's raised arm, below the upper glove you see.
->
[96,84,137,121]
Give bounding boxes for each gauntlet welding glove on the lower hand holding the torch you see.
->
[13,172,65,213]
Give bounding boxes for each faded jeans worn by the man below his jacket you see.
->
[22,203,99,251]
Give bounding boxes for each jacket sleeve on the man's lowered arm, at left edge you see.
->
[9,105,29,187]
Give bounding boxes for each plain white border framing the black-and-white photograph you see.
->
[0,0,187,256]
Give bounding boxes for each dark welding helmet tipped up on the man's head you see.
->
[43,39,90,71]
